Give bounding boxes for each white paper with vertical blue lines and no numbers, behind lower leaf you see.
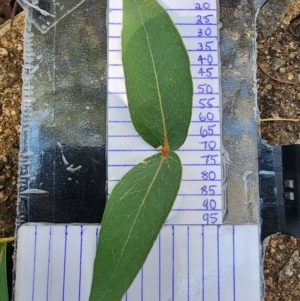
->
[15,225,261,301]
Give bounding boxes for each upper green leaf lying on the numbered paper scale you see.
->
[122,0,193,153]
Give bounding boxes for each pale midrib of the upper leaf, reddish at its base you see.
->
[134,0,169,150]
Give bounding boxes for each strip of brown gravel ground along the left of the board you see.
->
[0,11,24,237]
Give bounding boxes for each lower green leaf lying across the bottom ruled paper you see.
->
[90,152,182,301]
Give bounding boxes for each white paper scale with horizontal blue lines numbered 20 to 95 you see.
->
[107,0,222,225]
